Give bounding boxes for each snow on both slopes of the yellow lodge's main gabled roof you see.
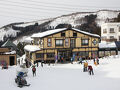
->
[32,28,100,38]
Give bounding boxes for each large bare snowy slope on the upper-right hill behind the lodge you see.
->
[50,10,120,27]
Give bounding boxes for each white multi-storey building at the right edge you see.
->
[101,22,120,42]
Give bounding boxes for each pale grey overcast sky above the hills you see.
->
[0,0,120,27]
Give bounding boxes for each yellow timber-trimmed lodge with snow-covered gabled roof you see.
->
[24,28,100,62]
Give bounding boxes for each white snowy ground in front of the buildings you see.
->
[0,56,120,90]
